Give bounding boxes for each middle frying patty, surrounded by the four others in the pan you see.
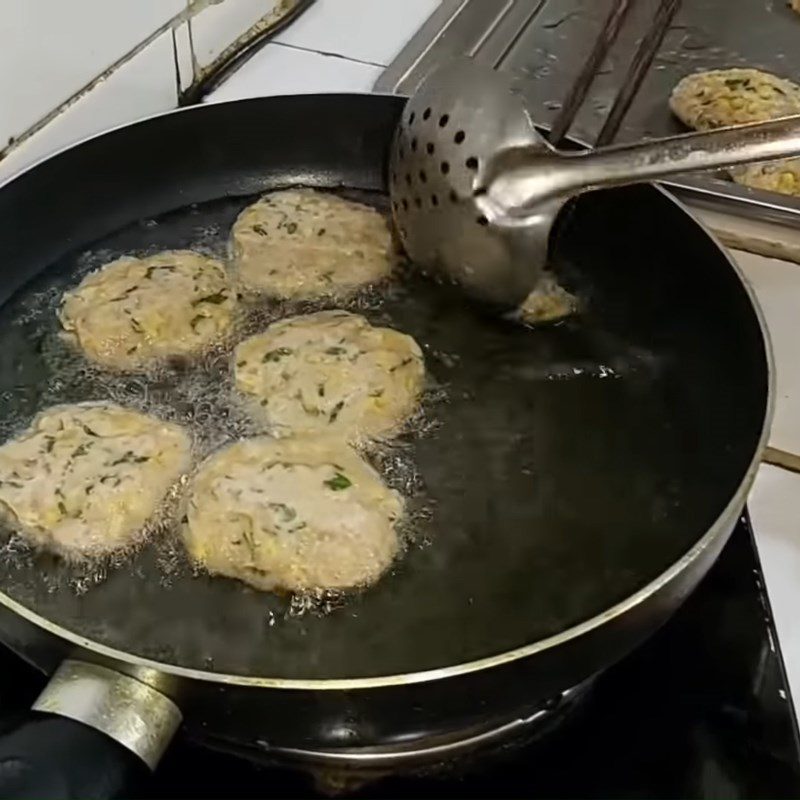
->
[233,311,425,442]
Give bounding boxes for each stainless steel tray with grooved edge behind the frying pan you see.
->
[375,0,800,228]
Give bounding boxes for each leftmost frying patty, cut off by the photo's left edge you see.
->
[0,403,191,559]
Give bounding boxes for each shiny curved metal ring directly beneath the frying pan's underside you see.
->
[206,677,595,795]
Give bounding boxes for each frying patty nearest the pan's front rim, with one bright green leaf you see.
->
[183,436,403,591]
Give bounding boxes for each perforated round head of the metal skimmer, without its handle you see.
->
[390,58,561,310]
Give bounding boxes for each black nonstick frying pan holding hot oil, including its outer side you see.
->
[0,95,770,795]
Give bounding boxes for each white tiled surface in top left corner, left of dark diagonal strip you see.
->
[0,0,290,182]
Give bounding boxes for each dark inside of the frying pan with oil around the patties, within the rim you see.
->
[0,95,768,678]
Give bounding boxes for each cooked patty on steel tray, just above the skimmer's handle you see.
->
[669,68,800,130]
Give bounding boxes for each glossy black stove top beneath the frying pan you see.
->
[0,519,800,800]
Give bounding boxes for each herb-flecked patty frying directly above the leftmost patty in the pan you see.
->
[59,250,236,370]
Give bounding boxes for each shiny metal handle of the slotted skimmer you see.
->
[478,116,800,224]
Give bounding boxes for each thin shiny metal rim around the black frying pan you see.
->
[0,98,775,691]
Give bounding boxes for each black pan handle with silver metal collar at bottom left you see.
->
[0,660,181,800]
